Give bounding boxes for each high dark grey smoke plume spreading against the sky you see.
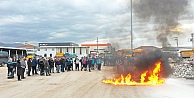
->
[133,0,188,46]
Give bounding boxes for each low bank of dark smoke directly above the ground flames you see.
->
[117,48,172,80]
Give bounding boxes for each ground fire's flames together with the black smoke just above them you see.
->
[102,49,172,85]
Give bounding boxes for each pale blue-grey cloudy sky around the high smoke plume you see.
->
[0,0,194,48]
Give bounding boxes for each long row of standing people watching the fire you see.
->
[7,56,102,81]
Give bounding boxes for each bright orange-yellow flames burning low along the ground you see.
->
[102,62,164,85]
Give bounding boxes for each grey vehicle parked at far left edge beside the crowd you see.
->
[0,51,8,66]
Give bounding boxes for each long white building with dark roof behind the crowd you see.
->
[36,42,89,57]
